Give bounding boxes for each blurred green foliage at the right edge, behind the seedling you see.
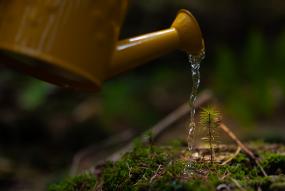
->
[211,31,285,124]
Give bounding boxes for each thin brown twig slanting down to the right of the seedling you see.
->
[219,122,268,176]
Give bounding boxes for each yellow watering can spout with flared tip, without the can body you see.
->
[107,9,204,78]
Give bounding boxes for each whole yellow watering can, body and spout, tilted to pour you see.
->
[0,0,204,90]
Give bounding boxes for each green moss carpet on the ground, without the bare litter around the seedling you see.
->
[50,143,285,191]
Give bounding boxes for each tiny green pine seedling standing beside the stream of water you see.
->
[199,106,220,163]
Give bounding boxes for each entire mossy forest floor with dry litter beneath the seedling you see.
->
[49,141,285,191]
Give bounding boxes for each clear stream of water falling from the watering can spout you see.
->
[187,51,205,151]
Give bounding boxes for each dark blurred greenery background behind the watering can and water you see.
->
[0,0,285,190]
